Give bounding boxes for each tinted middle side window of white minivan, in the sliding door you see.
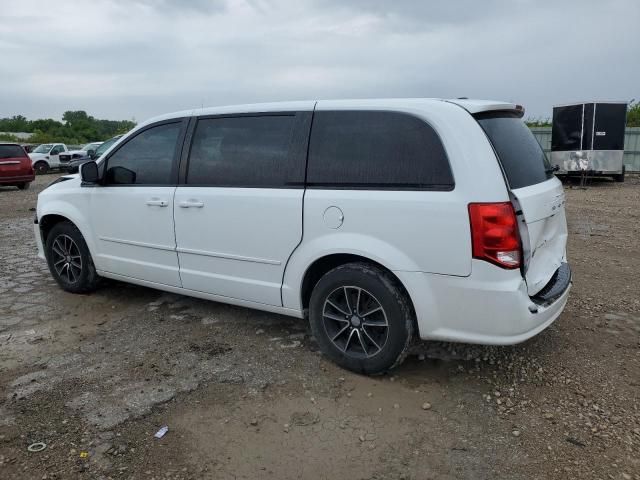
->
[187,114,304,187]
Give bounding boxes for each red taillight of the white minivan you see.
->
[469,202,521,268]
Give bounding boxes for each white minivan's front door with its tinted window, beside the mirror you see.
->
[90,120,184,287]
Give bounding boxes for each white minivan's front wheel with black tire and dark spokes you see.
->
[45,222,100,293]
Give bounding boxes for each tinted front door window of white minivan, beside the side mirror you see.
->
[105,122,181,185]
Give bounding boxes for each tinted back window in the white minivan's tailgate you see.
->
[475,112,553,189]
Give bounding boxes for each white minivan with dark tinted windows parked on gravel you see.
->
[35,99,571,374]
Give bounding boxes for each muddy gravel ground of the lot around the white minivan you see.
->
[0,175,640,480]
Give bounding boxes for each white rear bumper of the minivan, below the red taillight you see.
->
[395,260,571,345]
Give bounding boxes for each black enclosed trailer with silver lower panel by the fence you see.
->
[551,102,627,182]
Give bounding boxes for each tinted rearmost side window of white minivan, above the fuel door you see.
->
[307,111,453,190]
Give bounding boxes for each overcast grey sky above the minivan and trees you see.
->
[0,0,640,121]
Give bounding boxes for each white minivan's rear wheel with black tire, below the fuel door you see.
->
[309,263,415,375]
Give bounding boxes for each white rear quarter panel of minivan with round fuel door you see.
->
[282,101,509,309]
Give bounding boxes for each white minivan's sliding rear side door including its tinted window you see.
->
[175,112,311,305]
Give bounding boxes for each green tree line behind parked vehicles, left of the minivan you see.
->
[0,110,136,145]
